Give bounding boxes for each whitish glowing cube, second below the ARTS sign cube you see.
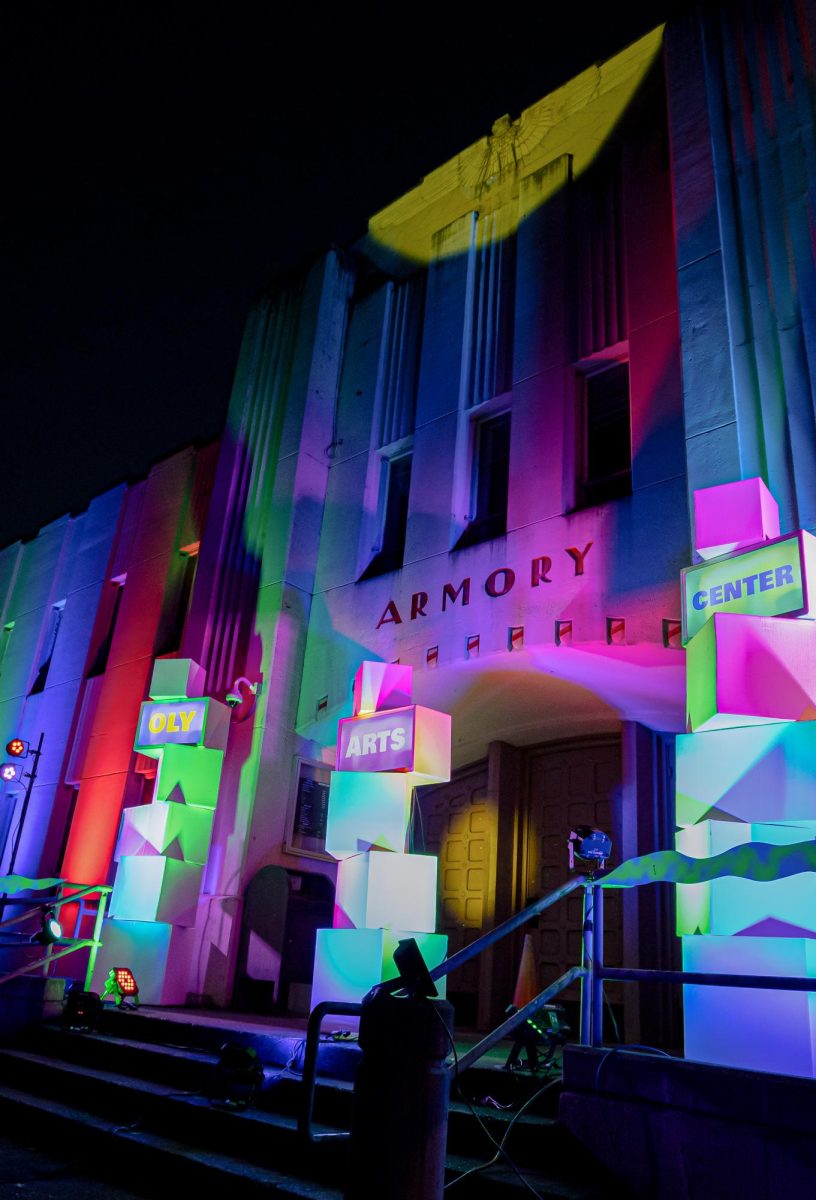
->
[335,851,437,934]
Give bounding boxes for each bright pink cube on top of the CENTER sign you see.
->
[694,478,779,558]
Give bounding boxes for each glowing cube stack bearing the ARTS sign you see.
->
[312,662,450,1008]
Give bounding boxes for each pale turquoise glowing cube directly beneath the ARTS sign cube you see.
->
[326,770,412,858]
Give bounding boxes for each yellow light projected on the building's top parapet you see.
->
[368,25,664,263]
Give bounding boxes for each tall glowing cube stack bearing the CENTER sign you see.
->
[677,479,816,1076]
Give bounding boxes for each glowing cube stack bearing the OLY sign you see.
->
[95,659,229,1004]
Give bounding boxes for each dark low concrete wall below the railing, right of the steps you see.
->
[559,1046,816,1200]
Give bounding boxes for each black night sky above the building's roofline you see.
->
[0,0,671,546]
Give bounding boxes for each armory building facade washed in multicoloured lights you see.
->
[0,7,816,1039]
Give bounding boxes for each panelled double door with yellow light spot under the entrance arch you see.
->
[416,734,623,1027]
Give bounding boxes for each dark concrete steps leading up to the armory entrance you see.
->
[0,1012,626,1200]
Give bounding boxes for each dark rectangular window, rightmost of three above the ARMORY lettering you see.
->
[576,362,632,506]
